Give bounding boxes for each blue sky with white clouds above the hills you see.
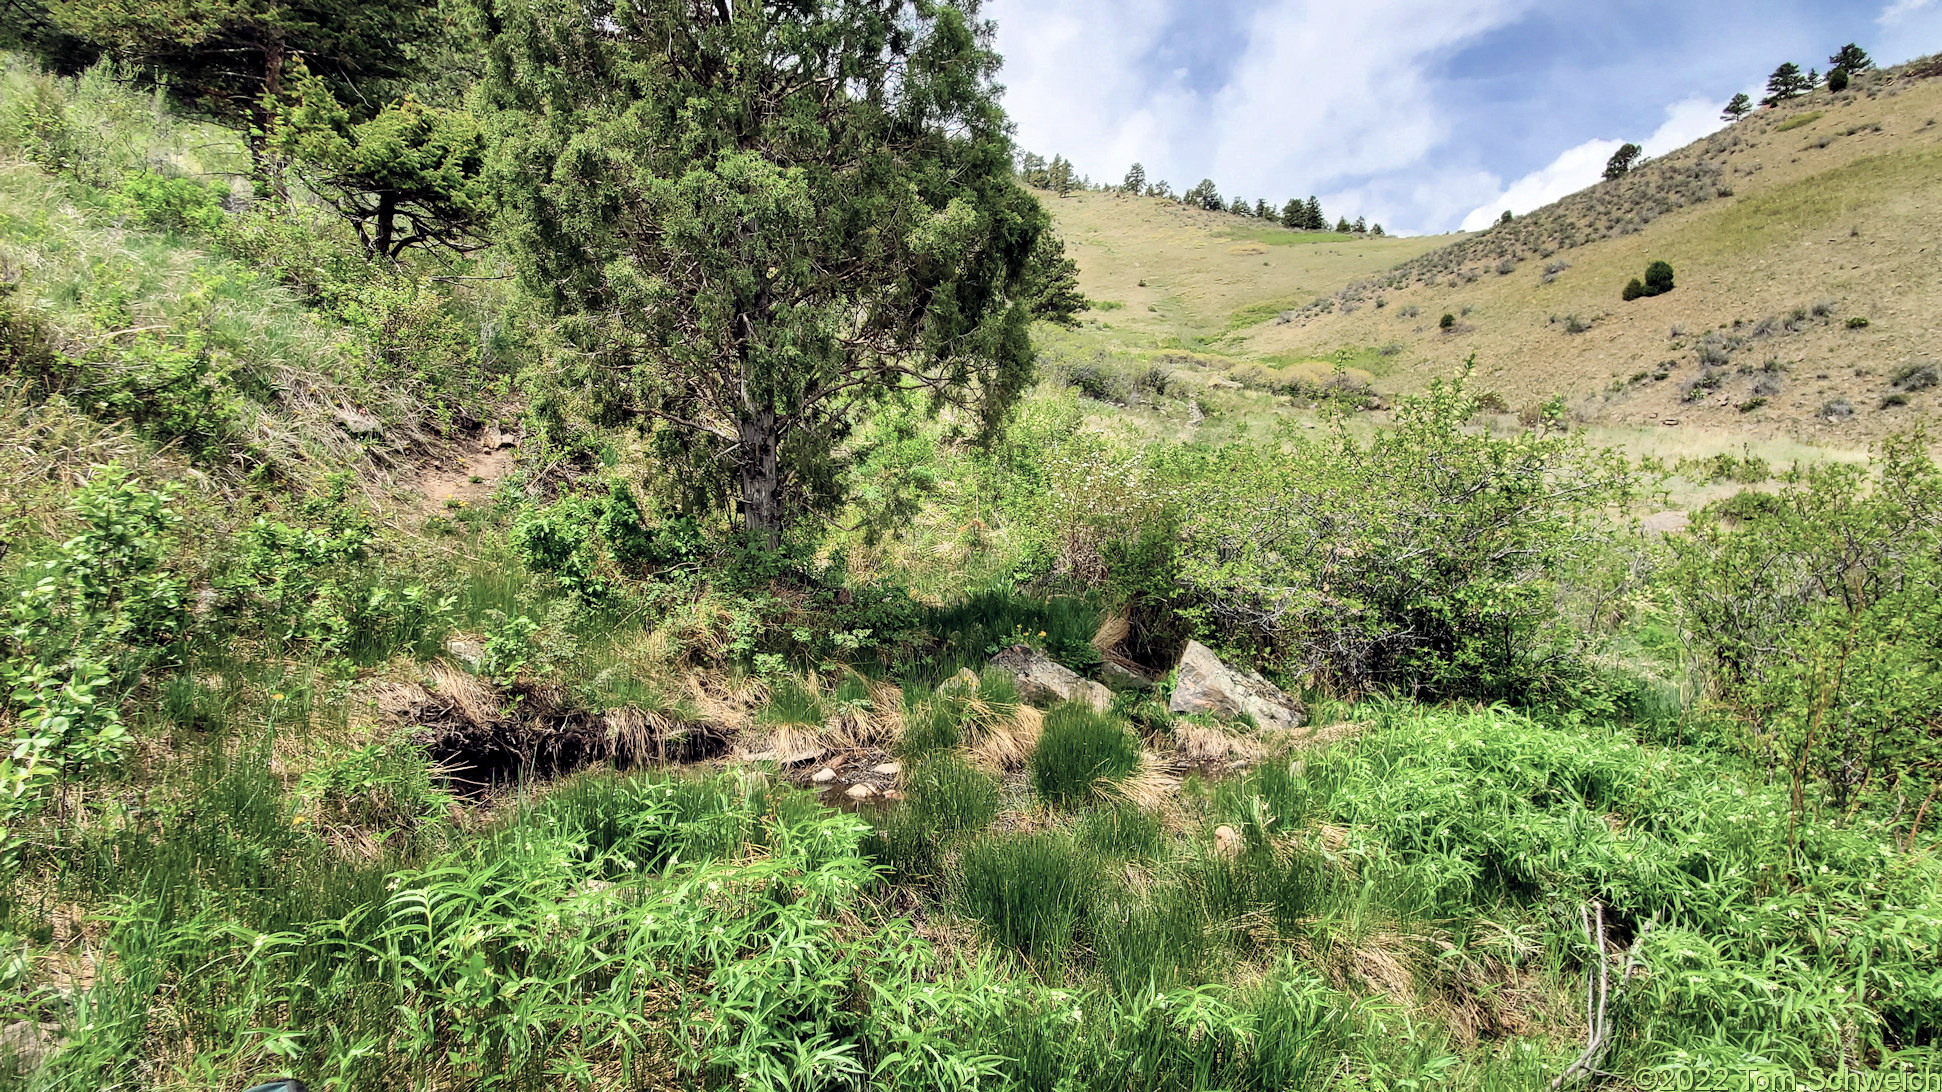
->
[985,0,1942,233]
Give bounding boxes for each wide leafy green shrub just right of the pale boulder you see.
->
[1179,363,1635,700]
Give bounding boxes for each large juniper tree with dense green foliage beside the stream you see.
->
[482,0,1074,546]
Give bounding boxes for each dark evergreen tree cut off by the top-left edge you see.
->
[36,0,437,181]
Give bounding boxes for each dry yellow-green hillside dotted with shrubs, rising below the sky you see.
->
[1049,64,1942,455]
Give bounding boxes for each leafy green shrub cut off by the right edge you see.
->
[1668,437,1942,810]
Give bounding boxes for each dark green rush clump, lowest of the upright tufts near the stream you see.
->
[957,834,1105,968]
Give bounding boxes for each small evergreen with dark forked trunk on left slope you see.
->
[270,62,487,258]
